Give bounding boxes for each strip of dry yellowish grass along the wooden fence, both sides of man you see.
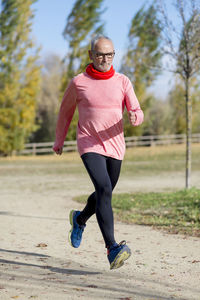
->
[0,144,200,177]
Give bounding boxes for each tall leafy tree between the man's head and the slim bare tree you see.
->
[121,4,161,134]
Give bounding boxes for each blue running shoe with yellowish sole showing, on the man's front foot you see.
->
[107,241,131,270]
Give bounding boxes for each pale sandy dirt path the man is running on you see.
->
[0,162,200,300]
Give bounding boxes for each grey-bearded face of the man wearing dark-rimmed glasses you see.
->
[89,38,114,72]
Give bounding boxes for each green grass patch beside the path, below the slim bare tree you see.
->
[74,188,200,237]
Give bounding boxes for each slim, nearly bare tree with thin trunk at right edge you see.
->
[157,0,200,188]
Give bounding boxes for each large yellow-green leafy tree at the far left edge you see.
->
[0,0,40,155]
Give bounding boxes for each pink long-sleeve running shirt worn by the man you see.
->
[53,72,143,160]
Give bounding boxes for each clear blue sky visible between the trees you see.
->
[32,0,178,98]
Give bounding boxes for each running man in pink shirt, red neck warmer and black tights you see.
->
[53,35,143,269]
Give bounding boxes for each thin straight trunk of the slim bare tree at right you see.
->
[185,78,192,189]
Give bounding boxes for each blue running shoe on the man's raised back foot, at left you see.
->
[69,210,86,248]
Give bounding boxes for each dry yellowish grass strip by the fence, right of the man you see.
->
[122,144,200,176]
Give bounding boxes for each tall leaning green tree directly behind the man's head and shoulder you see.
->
[61,0,104,139]
